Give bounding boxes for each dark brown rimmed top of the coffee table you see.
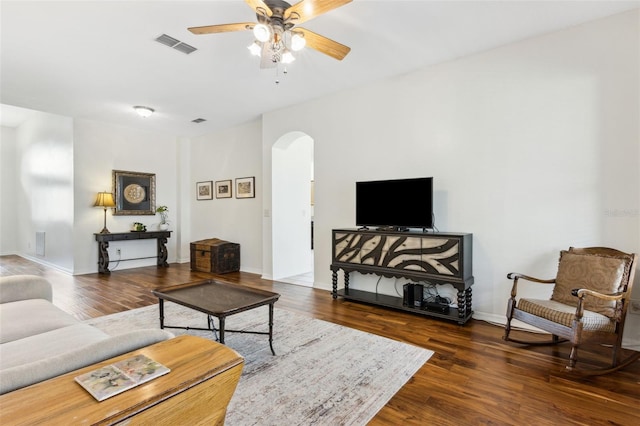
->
[153,280,280,317]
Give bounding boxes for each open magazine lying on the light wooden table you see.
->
[75,355,171,401]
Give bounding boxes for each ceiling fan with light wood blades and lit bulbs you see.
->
[189,0,352,68]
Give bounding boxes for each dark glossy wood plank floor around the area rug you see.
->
[0,256,640,425]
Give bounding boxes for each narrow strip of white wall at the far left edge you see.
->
[0,127,18,256]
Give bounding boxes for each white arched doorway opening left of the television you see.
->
[271,132,313,287]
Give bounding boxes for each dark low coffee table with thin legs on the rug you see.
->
[153,280,280,355]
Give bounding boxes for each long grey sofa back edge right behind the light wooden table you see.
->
[0,329,174,394]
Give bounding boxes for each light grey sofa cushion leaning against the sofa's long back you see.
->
[0,324,109,370]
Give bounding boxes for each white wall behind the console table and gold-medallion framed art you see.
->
[74,119,181,274]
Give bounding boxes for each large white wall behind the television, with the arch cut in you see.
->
[263,11,640,338]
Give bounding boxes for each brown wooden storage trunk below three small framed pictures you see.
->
[191,238,240,274]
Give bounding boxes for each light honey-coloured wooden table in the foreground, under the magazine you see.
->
[0,336,244,426]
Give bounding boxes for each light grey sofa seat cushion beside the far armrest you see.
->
[0,299,78,344]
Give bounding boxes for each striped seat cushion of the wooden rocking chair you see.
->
[518,299,616,333]
